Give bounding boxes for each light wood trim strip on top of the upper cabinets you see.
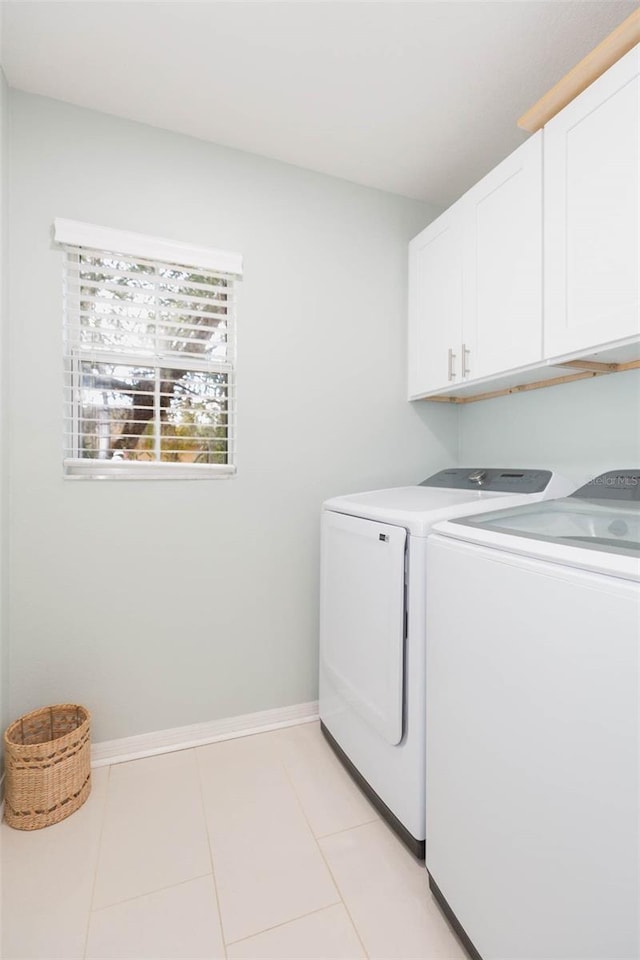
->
[518,8,640,133]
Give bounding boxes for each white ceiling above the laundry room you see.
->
[3,0,637,206]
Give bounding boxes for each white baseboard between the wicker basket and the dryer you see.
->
[91,701,318,767]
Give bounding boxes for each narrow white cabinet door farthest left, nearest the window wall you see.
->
[408,204,462,400]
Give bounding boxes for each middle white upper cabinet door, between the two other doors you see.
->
[461,131,542,379]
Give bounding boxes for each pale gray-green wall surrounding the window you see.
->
[9,91,457,740]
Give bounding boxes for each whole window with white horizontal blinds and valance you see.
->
[56,220,241,479]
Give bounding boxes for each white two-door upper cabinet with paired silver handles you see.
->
[409,133,542,399]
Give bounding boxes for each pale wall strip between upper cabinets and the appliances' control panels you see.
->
[460,370,640,484]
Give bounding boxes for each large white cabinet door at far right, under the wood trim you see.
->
[544,47,640,357]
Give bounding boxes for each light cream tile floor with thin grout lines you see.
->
[0,723,465,960]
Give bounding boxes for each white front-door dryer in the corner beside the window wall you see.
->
[320,467,574,857]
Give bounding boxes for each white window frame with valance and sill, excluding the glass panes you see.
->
[55,219,242,480]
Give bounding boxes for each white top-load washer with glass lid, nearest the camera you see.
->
[426,470,640,960]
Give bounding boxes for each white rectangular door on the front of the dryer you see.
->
[320,511,407,744]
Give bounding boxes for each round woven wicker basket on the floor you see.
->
[4,703,91,830]
